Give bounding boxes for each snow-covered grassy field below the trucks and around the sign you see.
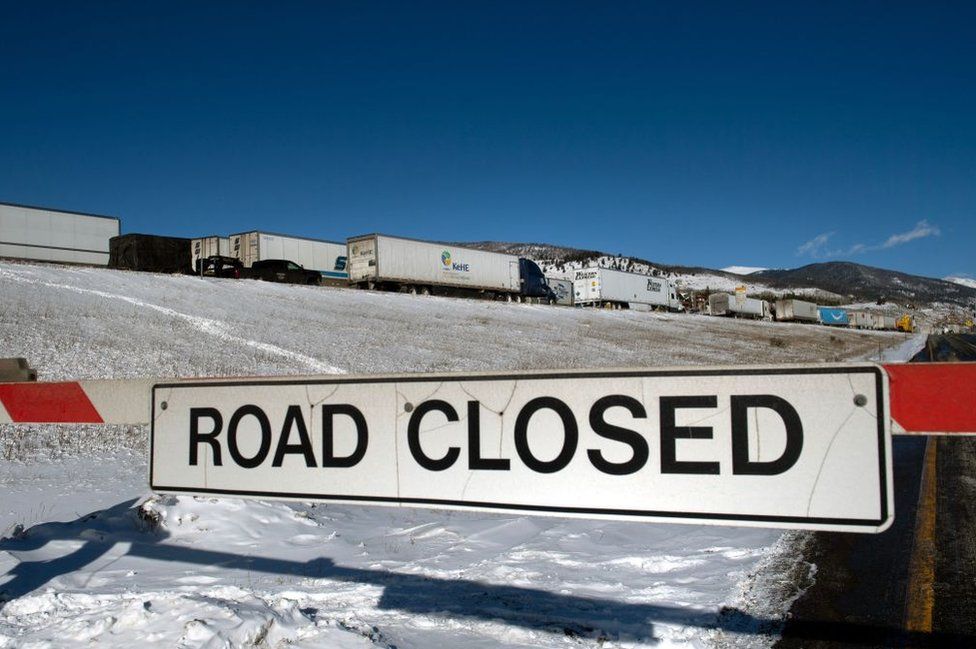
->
[0,263,918,648]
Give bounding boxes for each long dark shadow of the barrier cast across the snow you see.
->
[0,499,976,647]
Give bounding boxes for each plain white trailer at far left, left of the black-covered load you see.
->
[0,203,119,266]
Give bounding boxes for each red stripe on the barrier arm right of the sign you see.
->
[884,363,976,433]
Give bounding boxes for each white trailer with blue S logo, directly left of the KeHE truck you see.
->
[230,231,349,280]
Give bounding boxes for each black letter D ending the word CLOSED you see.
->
[732,394,803,475]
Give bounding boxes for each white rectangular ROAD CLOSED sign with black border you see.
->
[150,364,894,532]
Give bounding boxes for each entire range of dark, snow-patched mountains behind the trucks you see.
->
[457,241,976,307]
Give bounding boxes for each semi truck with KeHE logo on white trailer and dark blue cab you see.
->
[346,234,556,304]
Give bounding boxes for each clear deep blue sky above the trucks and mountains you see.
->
[0,1,976,276]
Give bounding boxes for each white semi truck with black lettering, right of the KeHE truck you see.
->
[573,268,683,311]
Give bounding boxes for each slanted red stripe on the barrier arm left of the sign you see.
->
[0,382,103,424]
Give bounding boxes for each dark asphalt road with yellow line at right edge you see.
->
[776,335,976,649]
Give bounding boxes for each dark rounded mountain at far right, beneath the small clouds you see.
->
[749,261,976,305]
